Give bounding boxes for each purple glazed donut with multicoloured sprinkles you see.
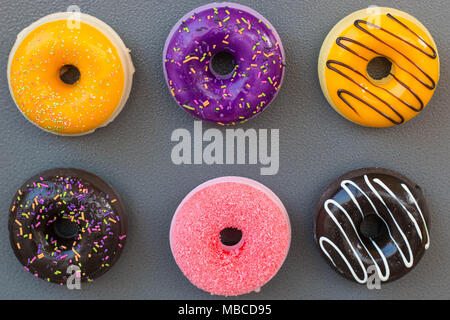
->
[163,2,285,125]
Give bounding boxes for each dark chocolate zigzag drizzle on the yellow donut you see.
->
[326,13,437,125]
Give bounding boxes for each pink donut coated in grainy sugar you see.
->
[170,177,291,296]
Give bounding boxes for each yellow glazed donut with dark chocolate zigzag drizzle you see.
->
[318,7,439,127]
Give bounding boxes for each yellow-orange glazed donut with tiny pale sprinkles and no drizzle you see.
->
[8,12,134,136]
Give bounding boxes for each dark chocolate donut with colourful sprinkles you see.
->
[9,169,127,285]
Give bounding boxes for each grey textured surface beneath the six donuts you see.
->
[0,0,450,299]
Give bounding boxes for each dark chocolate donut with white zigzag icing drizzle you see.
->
[313,168,430,284]
